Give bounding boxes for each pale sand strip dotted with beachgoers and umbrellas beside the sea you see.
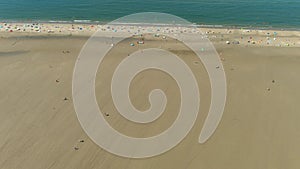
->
[0,22,300,47]
